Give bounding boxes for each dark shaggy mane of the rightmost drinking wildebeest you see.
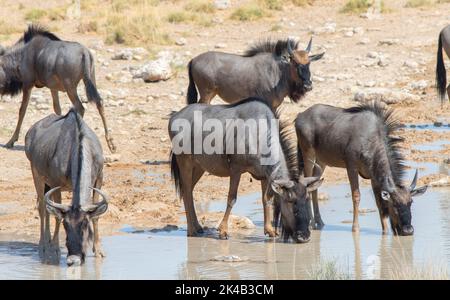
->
[344,102,406,187]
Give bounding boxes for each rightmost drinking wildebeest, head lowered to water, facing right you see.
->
[295,103,427,235]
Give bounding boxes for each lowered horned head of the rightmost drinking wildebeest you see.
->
[381,170,427,235]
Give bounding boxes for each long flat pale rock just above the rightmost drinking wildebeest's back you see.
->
[353,88,420,104]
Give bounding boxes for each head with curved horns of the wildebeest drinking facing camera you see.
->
[45,187,108,266]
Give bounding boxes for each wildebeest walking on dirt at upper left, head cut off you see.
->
[0,25,115,152]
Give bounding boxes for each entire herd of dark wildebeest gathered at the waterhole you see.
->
[0,25,450,265]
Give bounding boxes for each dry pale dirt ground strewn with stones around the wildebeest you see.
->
[0,0,450,238]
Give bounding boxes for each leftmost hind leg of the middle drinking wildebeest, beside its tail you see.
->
[177,156,203,236]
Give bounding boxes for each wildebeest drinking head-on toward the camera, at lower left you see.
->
[25,109,108,265]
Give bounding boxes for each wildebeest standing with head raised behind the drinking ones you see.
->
[187,38,324,109]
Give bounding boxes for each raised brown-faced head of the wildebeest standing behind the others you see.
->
[287,37,325,92]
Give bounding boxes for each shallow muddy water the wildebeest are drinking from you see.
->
[0,177,450,279]
